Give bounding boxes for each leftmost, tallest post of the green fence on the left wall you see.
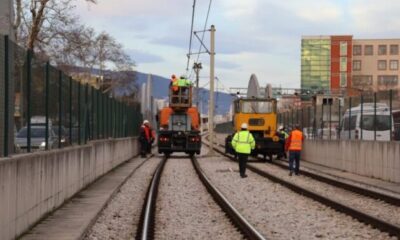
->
[3,35,10,157]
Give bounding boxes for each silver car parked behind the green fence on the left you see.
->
[15,126,57,152]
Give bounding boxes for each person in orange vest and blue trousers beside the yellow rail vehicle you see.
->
[285,124,304,176]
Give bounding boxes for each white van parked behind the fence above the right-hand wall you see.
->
[340,103,394,141]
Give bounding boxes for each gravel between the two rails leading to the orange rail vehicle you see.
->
[155,156,242,239]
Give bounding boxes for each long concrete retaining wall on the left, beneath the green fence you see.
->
[0,138,138,239]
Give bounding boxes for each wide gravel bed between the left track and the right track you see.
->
[200,146,395,239]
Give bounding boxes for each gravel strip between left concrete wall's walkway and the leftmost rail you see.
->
[85,157,161,240]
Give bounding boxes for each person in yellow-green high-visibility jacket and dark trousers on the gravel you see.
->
[232,123,256,178]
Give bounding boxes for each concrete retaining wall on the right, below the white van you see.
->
[302,140,400,183]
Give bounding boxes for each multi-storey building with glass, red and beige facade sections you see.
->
[301,35,400,93]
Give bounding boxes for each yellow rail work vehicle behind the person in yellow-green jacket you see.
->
[225,97,284,161]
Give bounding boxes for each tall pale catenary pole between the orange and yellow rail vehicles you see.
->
[208,25,215,156]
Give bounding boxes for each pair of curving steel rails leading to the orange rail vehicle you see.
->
[136,156,265,240]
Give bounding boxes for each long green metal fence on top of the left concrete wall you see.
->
[0,35,142,156]
